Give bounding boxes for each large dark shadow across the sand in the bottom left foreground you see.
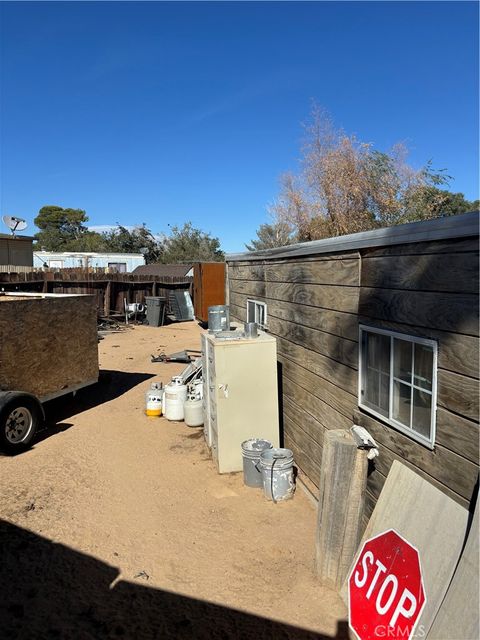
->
[0,521,348,640]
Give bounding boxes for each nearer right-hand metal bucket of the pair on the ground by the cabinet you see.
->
[259,449,295,503]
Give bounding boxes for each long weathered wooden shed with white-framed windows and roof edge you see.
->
[227,213,479,528]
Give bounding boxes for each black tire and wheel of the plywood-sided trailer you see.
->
[0,392,43,454]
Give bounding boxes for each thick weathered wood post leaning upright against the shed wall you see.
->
[315,429,368,590]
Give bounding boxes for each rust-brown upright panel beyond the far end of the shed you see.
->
[193,262,225,322]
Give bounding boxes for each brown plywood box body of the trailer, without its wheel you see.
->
[0,293,98,399]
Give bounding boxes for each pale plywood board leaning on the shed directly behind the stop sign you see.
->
[342,461,468,634]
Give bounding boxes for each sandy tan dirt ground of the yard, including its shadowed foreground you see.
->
[0,322,346,639]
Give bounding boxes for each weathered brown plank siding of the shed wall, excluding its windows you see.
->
[227,238,479,516]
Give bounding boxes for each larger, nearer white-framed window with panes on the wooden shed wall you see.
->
[358,325,437,449]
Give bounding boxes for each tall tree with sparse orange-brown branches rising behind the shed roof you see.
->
[271,105,448,241]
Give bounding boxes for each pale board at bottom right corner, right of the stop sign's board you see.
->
[427,498,480,640]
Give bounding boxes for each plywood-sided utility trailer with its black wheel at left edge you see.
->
[0,292,98,453]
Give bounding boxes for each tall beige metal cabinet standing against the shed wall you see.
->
[202,332,279,473]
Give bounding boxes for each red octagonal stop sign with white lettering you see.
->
[348,529,427,640]
